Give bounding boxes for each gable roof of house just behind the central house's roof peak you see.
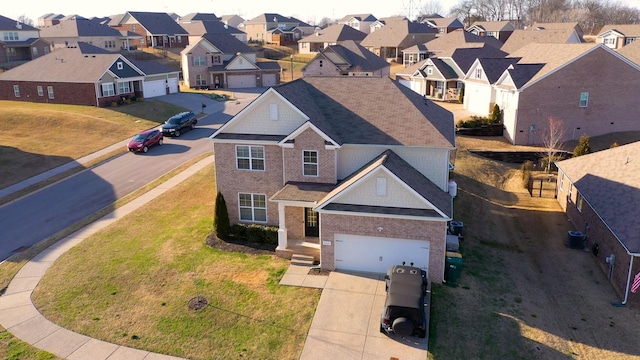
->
[303,40,391,71]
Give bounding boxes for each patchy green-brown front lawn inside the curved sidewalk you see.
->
[33,167,320,359]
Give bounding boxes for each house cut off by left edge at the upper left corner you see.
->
[0,15,50,69]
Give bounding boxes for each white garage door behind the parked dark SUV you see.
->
[335,234,429,273]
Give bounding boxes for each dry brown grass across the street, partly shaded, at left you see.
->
[0,101,188,188]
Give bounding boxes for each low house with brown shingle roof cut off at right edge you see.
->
[556,142,640,305]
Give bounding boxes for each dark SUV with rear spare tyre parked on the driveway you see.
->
[380,264,428,338]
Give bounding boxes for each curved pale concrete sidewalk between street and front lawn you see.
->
[0,156,214,360]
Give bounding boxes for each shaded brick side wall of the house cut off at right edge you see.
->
[558,175,640,306]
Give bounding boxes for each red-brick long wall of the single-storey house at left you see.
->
[0,81,97,106]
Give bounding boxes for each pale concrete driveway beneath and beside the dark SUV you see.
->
[300,271,428,360]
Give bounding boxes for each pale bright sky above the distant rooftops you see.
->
[5,0,640,24]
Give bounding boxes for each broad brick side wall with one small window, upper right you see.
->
[510,49,640,144]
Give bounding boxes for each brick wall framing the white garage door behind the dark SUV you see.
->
[320,214,447,283]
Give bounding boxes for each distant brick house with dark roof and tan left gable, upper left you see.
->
[109,11,189,48]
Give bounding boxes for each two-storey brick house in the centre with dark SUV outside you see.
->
[211,77,455,283]
